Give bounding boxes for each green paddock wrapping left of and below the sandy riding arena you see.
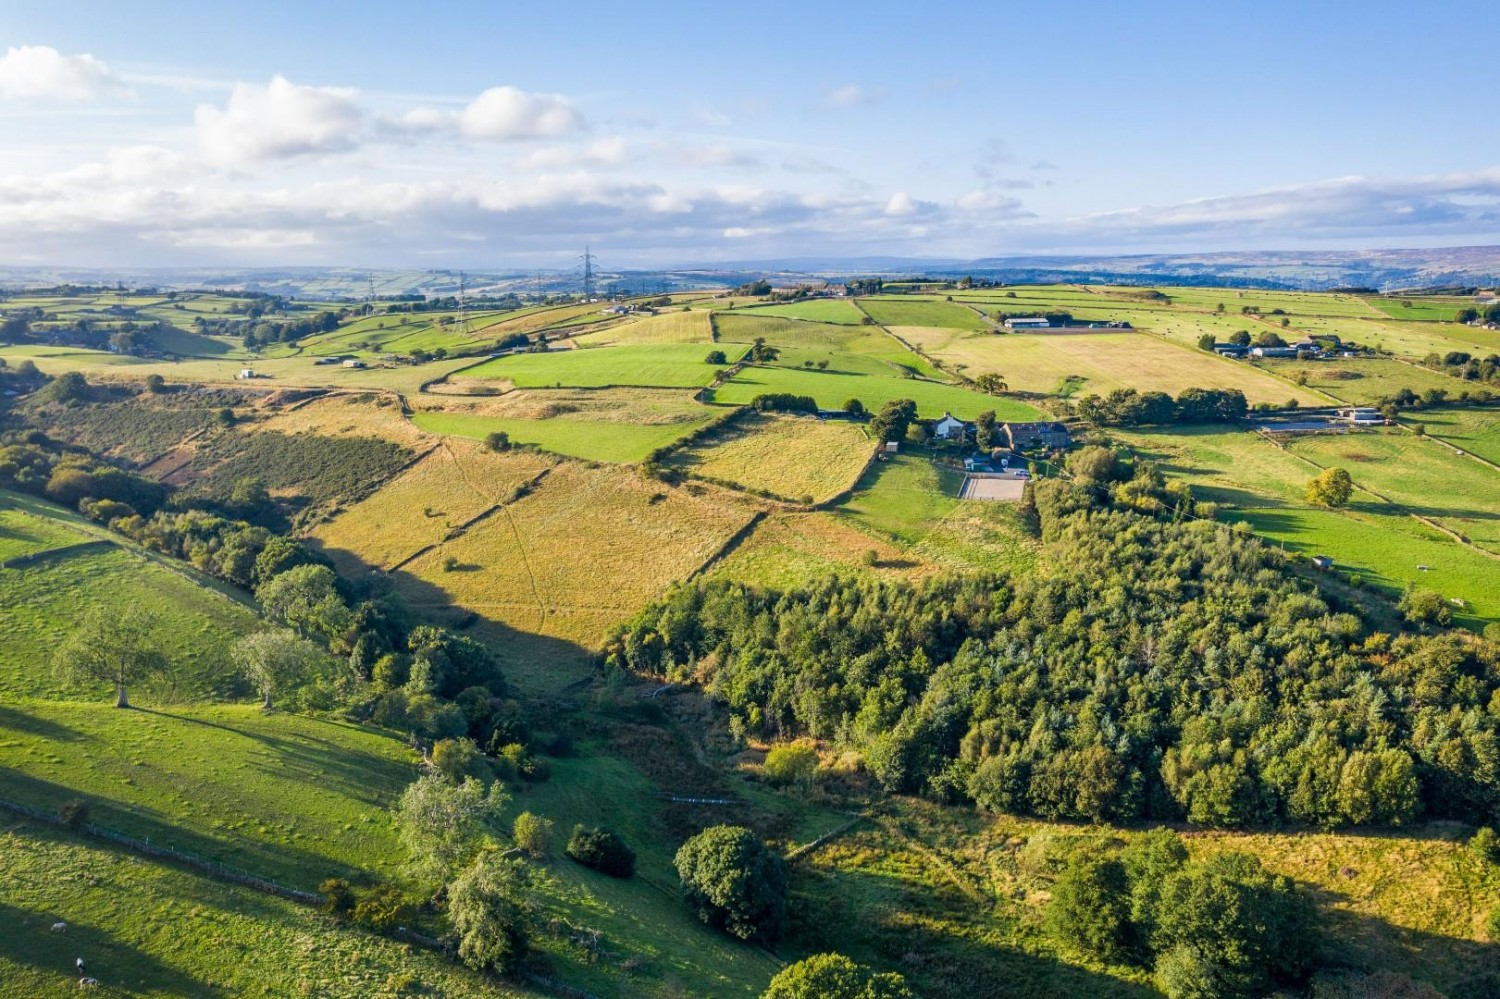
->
[837,455,1037,570]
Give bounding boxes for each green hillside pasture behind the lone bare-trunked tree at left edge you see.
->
[0,494,257,699]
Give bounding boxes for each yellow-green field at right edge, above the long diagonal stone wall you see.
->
[1289,431,1500,552]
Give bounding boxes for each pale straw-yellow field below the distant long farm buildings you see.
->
[893,327,1328,405]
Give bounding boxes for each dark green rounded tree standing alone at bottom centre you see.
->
[677,825,786,941]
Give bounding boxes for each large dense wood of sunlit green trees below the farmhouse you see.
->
[606,471,1500,827]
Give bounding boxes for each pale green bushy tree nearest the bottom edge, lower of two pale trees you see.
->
[449,854,530,975]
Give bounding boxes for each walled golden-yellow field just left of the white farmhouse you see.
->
[668,414,875,503]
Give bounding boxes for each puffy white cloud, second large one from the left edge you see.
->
[195,77,365,167]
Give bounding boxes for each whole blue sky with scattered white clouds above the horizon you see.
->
[0,2,1500,267]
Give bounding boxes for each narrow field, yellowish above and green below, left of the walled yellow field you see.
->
[413,389,717,462]
